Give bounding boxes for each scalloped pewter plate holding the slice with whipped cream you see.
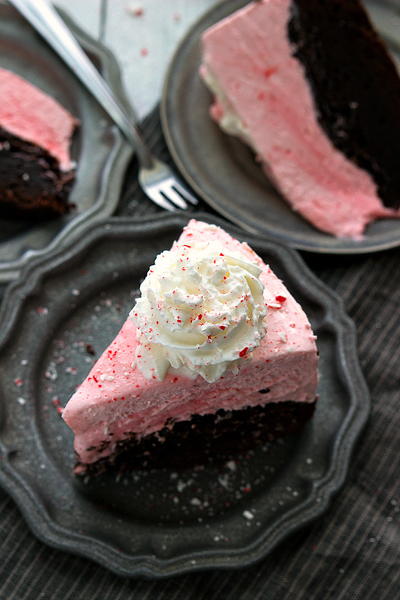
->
[0,213,369,577]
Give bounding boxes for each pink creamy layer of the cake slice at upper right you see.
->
[202,0,400,239]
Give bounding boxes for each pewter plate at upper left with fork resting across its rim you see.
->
[0,4,131,282]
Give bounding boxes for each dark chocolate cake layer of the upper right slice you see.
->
[288,0,400,208]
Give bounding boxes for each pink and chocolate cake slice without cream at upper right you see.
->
[201,0,400,239]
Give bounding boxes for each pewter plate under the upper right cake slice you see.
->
[161,0,400,254]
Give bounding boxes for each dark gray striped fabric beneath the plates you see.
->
[0,113,400,600]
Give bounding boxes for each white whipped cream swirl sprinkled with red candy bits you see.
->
[130,242,266,382]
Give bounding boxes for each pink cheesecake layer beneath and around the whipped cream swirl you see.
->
[63,220,317,463]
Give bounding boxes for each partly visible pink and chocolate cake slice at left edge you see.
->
[0,69,77,220]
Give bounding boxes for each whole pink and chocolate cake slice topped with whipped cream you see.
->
[63,220,317,472]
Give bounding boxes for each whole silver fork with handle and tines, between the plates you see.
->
[9,0,197,211]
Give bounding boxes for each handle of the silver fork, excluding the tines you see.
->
[9,0,153,167]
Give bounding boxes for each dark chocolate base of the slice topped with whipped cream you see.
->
[75,399,317,476]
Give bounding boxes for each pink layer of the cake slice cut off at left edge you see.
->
[0,68,78,171]
